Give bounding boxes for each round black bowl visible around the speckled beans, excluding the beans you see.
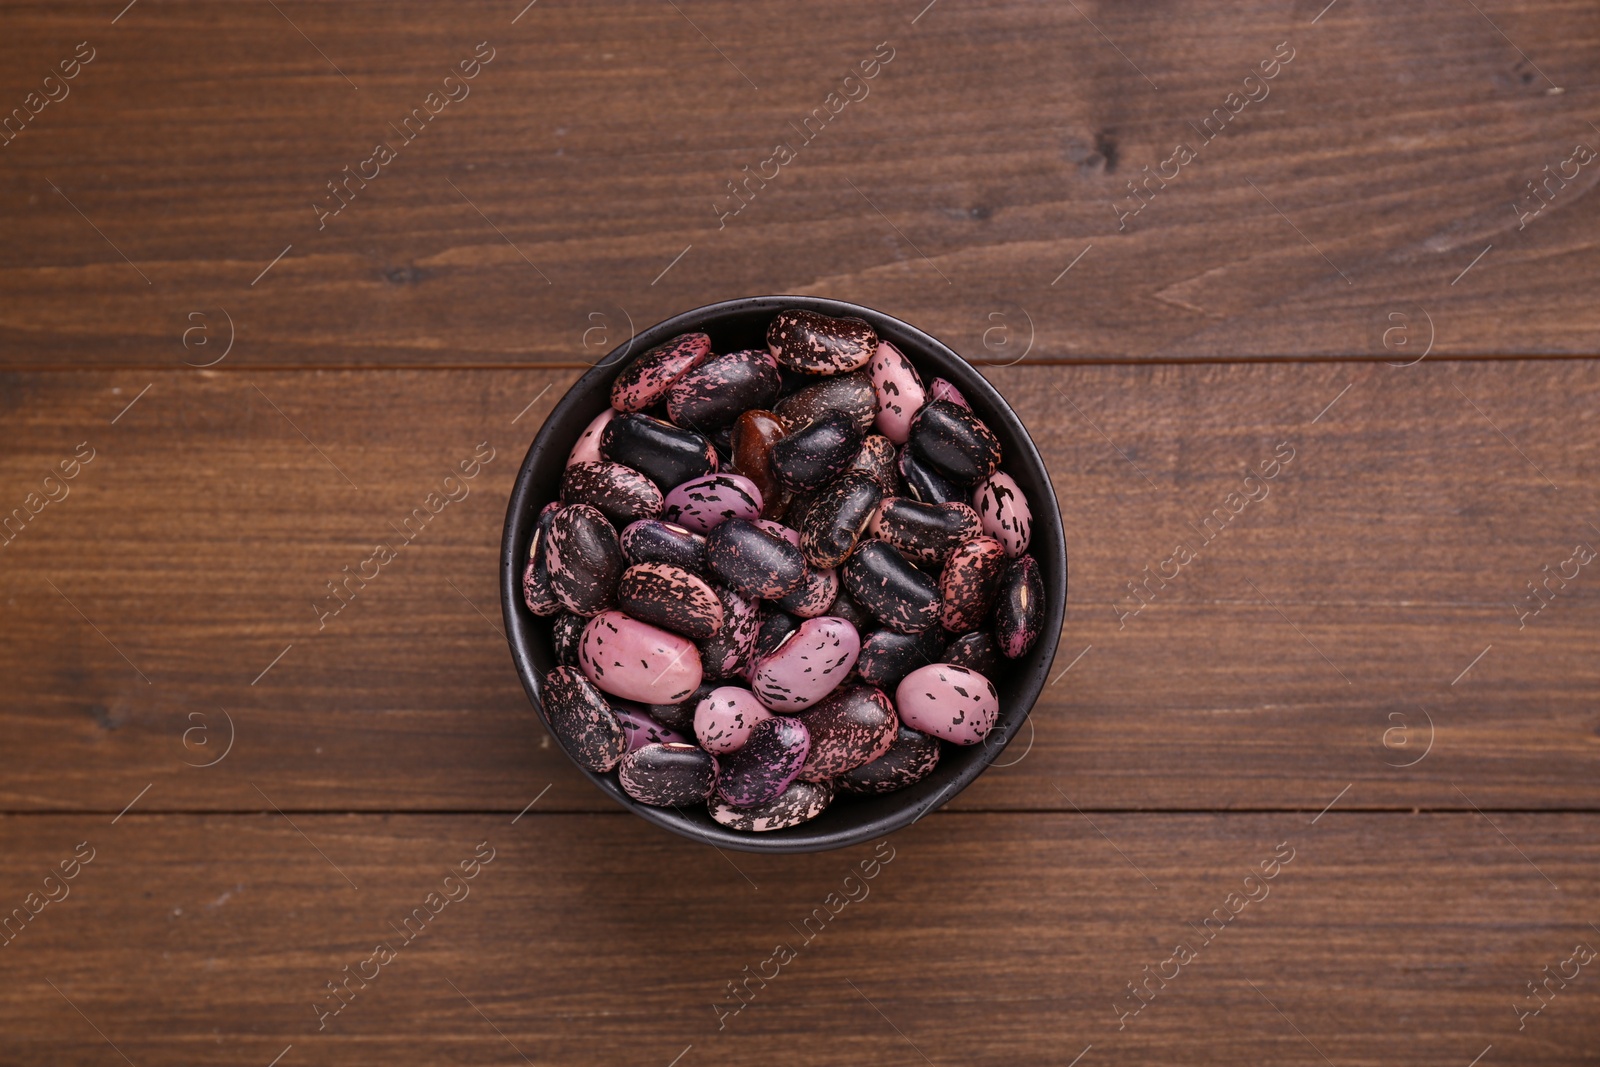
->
[501,296,1067,853]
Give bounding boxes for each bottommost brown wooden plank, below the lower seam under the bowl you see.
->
[0,808,1600,1067]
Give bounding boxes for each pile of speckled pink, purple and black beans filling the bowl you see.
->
[523,310,1045,830]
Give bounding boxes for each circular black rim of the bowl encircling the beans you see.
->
[501,296,1069,853]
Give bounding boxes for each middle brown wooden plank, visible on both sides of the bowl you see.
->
[0,358,1600,814]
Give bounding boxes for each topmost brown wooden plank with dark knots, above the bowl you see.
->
[0,0,1600,366]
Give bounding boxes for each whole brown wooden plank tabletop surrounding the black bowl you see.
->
[0,0,1600,1067]
